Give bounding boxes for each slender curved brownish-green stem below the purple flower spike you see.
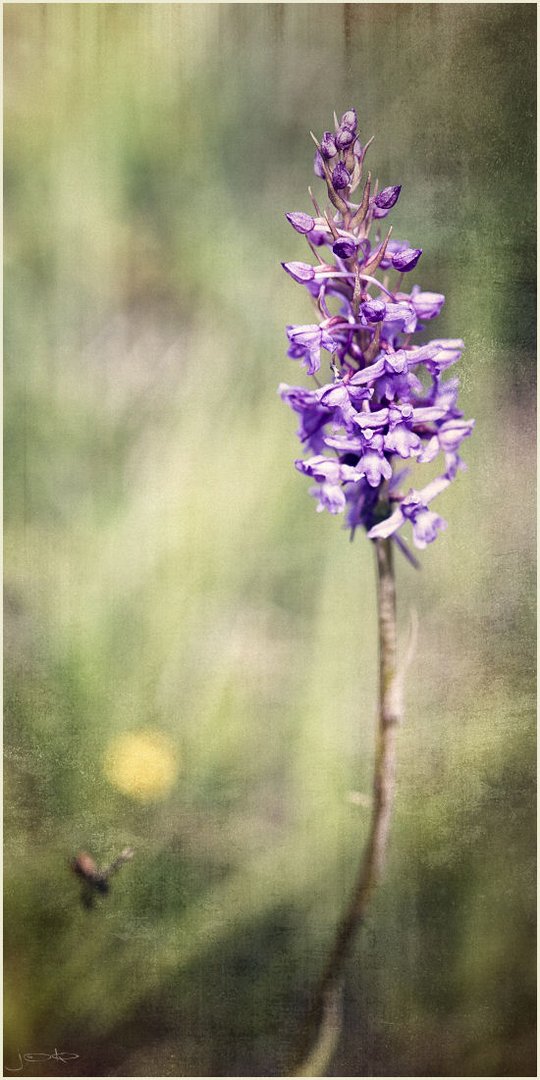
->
[289,539,401,1076]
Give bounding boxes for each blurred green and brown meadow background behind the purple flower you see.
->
[4,4,536,1076]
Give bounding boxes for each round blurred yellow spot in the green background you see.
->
[104,730,178,802]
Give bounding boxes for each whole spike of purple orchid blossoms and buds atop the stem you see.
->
[280,109,474,550]
